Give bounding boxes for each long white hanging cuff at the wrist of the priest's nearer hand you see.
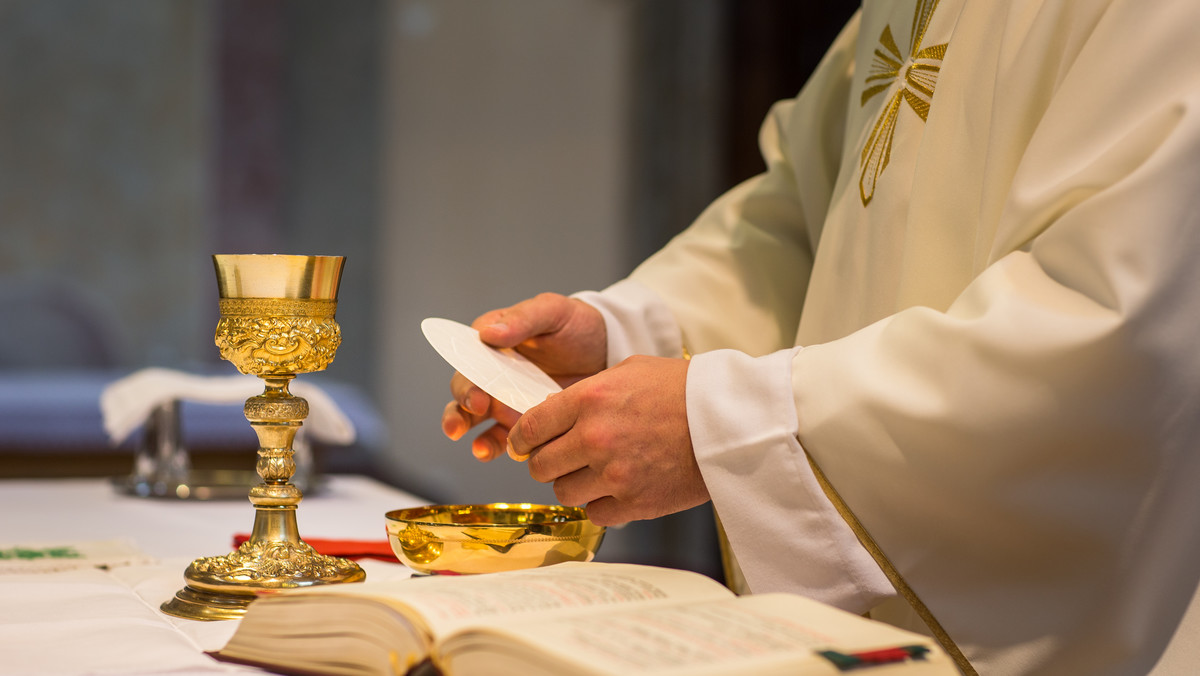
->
[686,347,895,612]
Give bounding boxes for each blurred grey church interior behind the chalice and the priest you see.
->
[0,0,857,576]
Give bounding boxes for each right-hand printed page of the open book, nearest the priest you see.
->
[439,594,956,675]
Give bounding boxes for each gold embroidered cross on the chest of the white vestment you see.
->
[858,0,946,207]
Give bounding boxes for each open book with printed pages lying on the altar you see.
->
[214,562,958,676]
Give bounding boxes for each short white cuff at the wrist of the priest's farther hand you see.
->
[571,280,683,366]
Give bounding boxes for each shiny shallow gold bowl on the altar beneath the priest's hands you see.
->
[386,502,605,575]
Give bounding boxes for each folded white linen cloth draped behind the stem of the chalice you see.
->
[100,367,355,445]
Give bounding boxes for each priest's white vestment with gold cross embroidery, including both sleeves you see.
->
[583,0,1200,675]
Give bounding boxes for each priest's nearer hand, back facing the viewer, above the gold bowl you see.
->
[509,357,708,526]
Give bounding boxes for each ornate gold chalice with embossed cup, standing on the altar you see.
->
[162,255,366,620]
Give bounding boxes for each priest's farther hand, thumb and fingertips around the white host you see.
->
[442,293,608,462]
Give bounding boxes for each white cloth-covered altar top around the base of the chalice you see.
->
[0,474,424,676]
